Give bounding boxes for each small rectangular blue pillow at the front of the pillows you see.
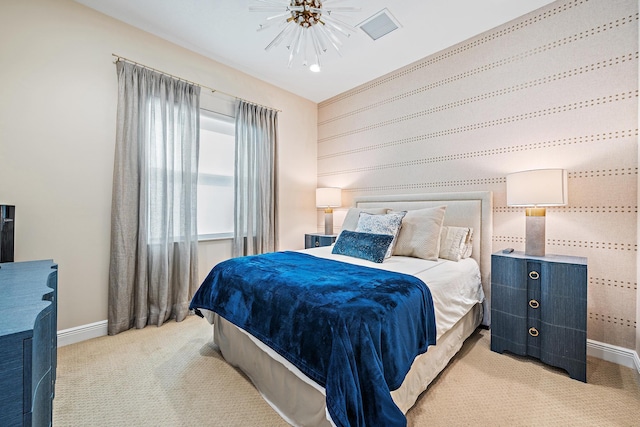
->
[331,230,393,263]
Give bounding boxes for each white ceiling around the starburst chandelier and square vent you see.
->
[75,0,552,102]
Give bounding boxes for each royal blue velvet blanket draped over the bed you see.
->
[190,252,436,426]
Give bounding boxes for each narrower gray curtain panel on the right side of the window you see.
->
[233,101,278,257]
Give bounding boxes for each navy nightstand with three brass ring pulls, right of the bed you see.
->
[491,252,587,382]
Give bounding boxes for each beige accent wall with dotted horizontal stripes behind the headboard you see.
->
[318,0,638,349]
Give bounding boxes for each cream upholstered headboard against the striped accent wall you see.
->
[355,191,493,326]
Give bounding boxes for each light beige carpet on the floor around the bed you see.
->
[53,316,640,427]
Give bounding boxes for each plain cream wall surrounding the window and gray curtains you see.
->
[0,0,317,330]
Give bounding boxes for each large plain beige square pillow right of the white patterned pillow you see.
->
[393,206,446,261]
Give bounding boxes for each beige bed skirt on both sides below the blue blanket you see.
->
[207,304,483,426]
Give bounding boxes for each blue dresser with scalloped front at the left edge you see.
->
[0,261,58,427]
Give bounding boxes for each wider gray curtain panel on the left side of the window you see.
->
[108,61,200,335]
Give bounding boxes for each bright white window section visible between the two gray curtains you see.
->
[198,110,235,240]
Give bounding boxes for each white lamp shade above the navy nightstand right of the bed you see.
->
[507,169,569,206]
